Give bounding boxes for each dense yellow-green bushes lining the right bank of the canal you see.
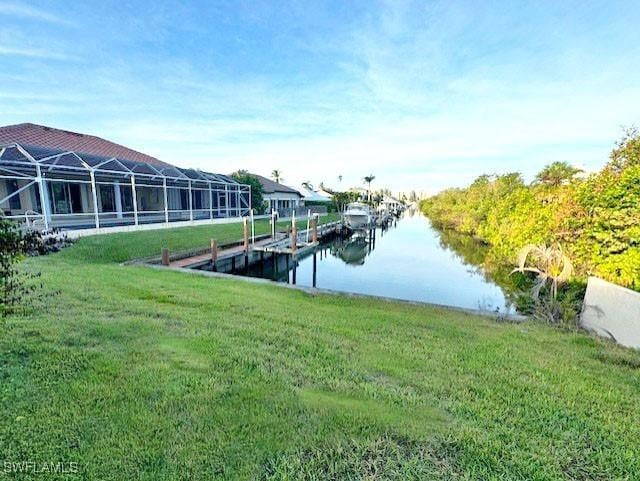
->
[421,130,640,290]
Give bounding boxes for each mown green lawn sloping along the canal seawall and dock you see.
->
[0,219,640,481]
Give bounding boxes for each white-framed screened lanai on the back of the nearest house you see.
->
[0,143,251,230]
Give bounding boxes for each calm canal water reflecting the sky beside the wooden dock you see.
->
[234,211,515,313]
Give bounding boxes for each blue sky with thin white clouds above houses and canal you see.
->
[0,0,640,193]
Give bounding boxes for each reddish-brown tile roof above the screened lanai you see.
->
[0,123,171,167]
